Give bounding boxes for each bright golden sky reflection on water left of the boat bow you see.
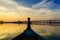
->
[0,24,26,40]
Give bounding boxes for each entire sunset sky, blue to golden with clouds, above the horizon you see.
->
[0,0,60,21]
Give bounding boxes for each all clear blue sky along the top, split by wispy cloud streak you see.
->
[14,0,60,9]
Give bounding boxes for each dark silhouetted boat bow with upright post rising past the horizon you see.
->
[12,18,46,40]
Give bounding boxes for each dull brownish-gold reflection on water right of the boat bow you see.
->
[32,25,60,36]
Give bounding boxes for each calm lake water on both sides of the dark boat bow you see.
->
[0,24,60,40]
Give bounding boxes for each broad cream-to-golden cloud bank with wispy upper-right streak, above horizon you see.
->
[0,0,60,20]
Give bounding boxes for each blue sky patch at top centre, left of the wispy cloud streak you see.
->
[14,0,42,7]
